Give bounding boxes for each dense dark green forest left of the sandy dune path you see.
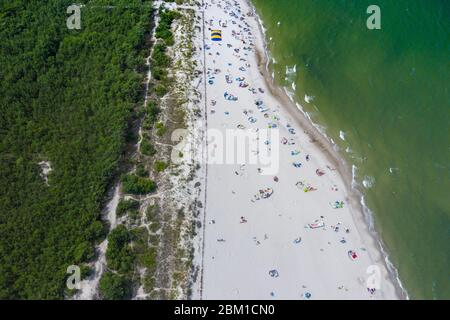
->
[0,0,153,299]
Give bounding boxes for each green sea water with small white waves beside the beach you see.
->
[252,0,450,299]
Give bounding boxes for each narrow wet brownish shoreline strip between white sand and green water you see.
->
[244,0,409,300]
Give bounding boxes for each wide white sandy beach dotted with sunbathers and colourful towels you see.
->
[193,0,400,299]
